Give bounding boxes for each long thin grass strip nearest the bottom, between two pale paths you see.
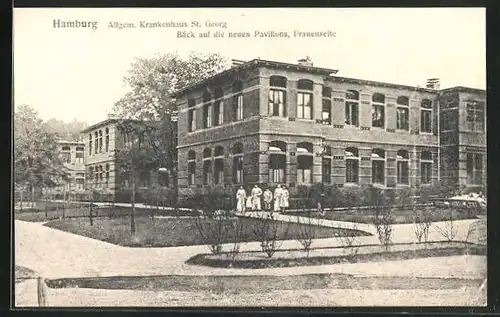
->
[47,273,482,294]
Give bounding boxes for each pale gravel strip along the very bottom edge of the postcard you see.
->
[44,288,483,307]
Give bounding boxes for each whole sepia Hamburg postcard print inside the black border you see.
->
[11,8,488,309]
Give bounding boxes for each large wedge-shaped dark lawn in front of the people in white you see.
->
[45,216,369,247]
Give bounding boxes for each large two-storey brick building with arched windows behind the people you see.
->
[175,60,486,196]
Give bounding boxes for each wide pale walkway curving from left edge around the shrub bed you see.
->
[15,215,483,278]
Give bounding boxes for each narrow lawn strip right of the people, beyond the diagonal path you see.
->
[286,207,477,224]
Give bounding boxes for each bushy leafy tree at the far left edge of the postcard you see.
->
[14,105,69,204]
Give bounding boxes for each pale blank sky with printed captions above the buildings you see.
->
[13,8,486,124]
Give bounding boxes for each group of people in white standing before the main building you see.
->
[236,185,290,213]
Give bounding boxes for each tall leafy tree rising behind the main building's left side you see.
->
[113,53,228,207]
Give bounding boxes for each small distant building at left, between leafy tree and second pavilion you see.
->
[56,140,85,200]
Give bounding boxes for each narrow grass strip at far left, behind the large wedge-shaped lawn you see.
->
[14,204,194,222]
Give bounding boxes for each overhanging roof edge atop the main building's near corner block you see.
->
[172,59,338,97]
